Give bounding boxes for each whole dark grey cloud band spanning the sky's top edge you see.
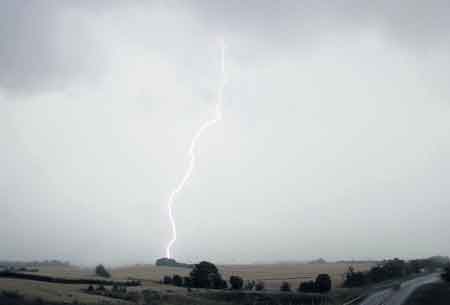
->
[0,0,450,93]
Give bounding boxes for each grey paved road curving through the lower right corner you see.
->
[360,273,439,305]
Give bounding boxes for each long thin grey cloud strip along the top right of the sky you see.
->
[192,0,450,46]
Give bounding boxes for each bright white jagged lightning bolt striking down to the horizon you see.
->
[166,39,226,258]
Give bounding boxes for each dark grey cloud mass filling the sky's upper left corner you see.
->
[0,1,101,94]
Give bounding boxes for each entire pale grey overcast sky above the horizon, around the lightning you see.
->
[0,0,450,265]
